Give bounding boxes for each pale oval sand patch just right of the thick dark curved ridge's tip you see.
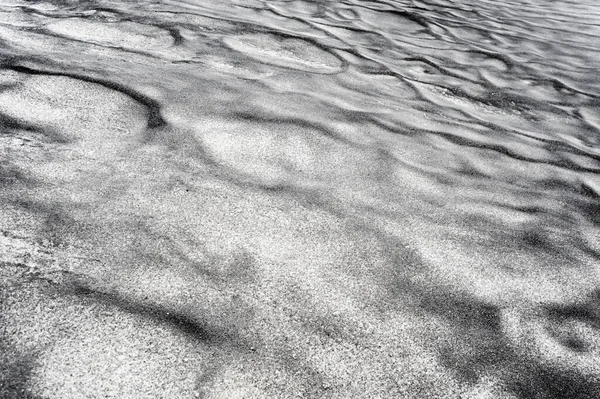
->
[195,121,385,185]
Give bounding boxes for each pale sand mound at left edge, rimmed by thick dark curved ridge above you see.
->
[0,72,147,149]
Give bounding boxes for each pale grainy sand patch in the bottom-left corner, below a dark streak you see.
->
[0,284,212,399]
